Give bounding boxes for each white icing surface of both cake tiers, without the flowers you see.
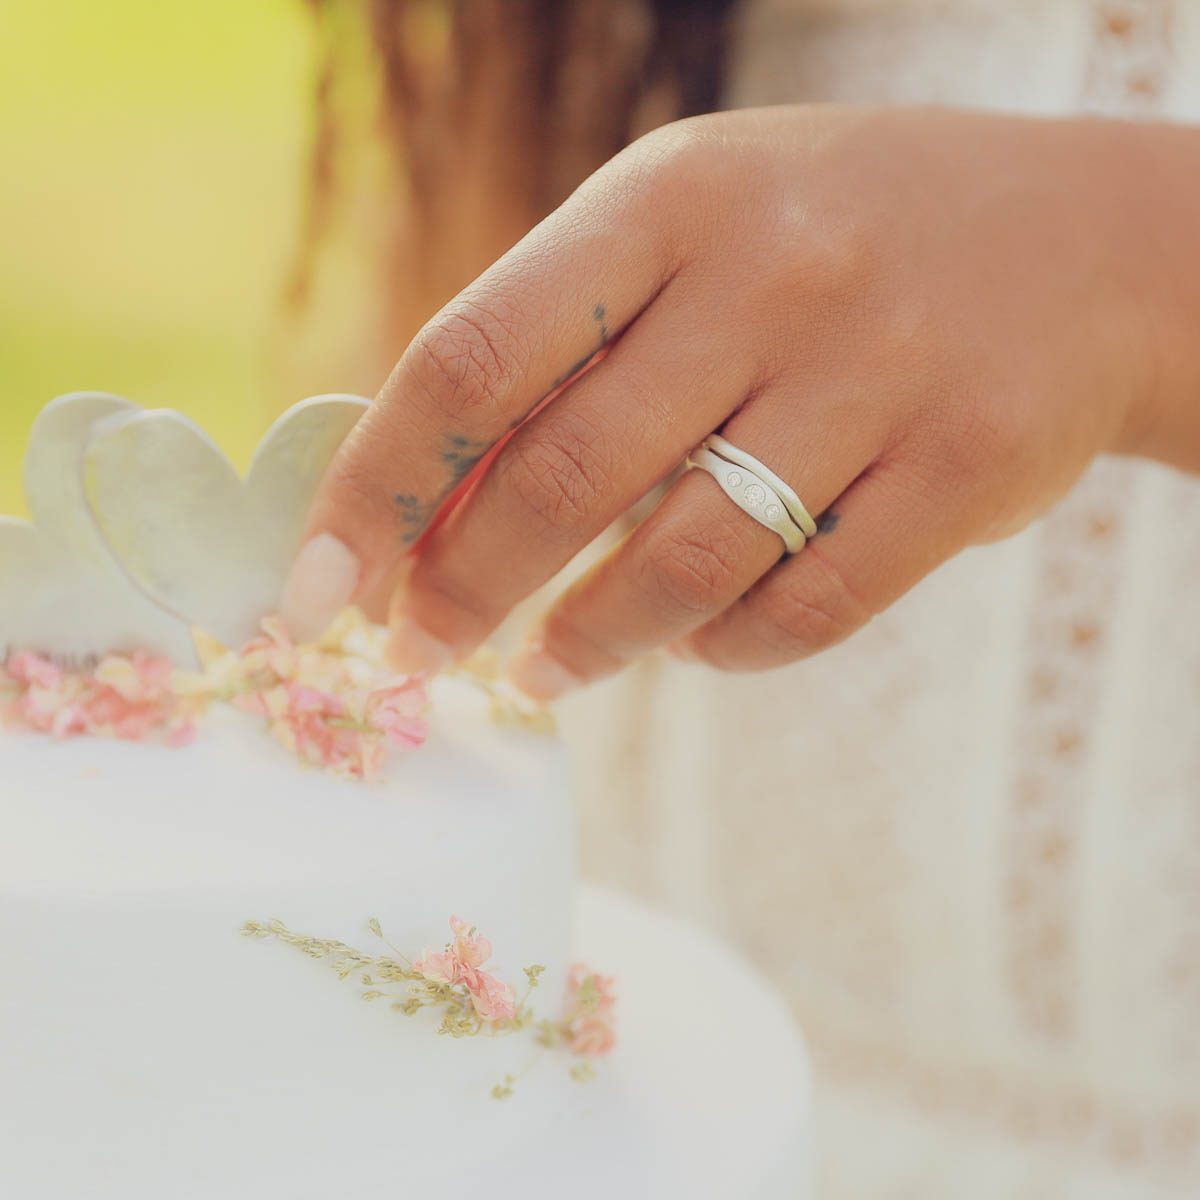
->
[0,683,810,1200]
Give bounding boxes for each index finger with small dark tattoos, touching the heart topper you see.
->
[282,158,677,640]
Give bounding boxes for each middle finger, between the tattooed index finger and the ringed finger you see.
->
[389,281,750,671]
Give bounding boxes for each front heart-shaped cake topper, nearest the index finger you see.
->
[83,396,367,646]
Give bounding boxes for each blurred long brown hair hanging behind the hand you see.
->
[287,0,736,369]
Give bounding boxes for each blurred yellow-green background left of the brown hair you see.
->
[0,0,314,512]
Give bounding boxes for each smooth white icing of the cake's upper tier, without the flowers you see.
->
[0,680,577,1200]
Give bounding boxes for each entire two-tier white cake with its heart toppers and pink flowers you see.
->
[0,394,810,1200]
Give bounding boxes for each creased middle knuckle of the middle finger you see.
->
[498,418,614,536]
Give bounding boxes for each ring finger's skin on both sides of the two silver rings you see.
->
[501,391,878,700]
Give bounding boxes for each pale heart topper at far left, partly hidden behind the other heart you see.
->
[0,391,192,662]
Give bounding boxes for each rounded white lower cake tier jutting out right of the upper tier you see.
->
[556,884,817,1200]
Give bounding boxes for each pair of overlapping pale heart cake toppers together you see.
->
[0,392,367,665]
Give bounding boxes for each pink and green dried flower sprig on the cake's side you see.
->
[241,917,617,1099]
